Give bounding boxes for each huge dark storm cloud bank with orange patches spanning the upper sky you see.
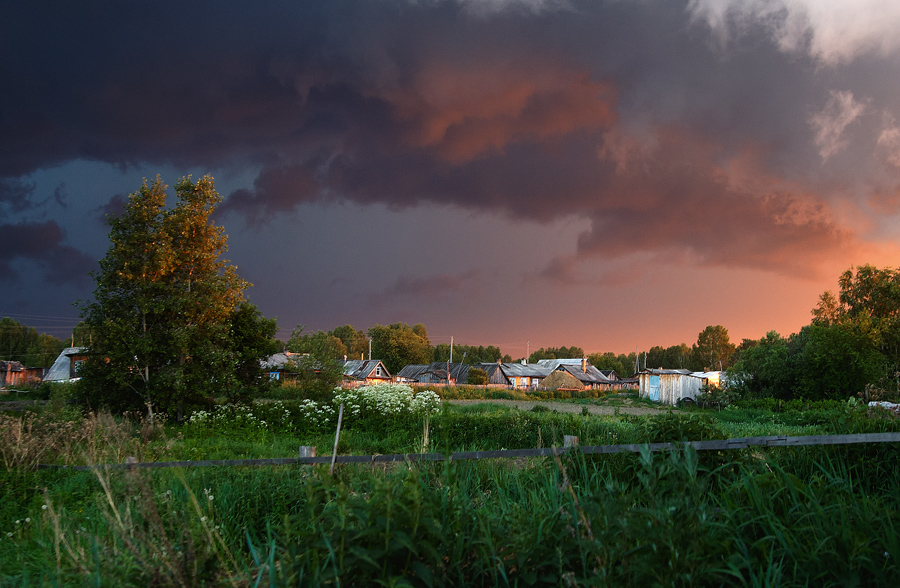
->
[0,1,900,279]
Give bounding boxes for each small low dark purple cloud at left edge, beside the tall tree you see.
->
[0,221,97,284]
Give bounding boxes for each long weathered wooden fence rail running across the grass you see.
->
[37,433,900,470]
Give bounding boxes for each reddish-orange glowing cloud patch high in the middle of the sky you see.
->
[388,63,615,164]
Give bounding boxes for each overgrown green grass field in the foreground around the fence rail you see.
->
[0,388,900,586]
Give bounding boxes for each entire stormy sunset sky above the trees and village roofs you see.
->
[0,0,900,357]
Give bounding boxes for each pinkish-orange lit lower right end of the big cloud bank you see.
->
[577,128,863,278]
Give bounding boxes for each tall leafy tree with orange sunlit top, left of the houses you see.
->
[81,176,274,415]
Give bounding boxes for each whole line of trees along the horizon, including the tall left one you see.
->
[8,176,900,418]
